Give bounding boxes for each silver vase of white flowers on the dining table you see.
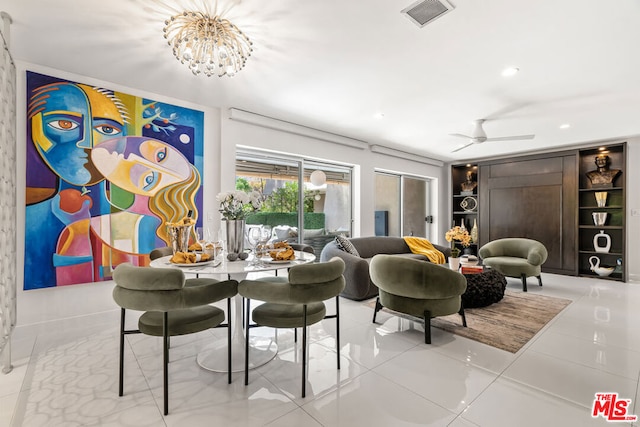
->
[216,190,262,261]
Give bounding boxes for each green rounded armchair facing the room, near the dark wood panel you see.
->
[478,237,548,292]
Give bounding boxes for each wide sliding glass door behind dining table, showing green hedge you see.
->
[236,151,352,257]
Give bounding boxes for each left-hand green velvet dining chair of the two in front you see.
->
[113,263,238,415]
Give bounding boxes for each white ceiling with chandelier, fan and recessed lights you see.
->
[0,0,640,161]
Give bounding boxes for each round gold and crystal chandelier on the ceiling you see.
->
[163,12,253,77]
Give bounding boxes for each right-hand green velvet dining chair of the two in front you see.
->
[238,258,345,397]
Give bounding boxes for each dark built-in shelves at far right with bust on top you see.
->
[578,144,627,281]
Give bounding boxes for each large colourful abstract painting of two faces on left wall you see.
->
[24,71,204,290]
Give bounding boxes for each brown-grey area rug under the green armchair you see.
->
[374,290,571,353]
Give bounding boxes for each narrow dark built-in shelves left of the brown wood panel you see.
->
[451,164,480,255]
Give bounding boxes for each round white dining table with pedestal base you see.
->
[150,251,316,372]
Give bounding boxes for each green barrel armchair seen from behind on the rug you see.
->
[369,255,467,344]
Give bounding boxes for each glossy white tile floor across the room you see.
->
[0,274,640,427]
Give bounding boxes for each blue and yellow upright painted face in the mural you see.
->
[29,83,124,186]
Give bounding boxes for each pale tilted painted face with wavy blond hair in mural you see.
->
[91,136,191,197]
